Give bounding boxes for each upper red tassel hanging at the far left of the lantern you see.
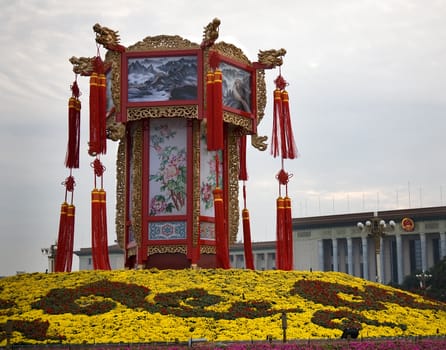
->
[65,81,81,169]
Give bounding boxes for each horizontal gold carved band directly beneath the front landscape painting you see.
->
[127,105,198,121]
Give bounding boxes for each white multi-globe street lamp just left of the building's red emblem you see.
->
[357,212,396,283]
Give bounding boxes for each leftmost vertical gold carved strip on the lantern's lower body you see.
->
[115,138,127,248]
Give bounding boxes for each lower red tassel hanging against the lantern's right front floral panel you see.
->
[213,187,230,269]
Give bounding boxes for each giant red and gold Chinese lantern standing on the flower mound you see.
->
[57,19,298,269]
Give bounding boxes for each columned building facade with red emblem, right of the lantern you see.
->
[293,207,446,284]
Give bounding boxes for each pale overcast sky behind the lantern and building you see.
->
[0,0,446,276]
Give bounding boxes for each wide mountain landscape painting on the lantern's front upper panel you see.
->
[127,56,198,102]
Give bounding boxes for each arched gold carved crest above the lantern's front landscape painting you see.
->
[126,35,200,52]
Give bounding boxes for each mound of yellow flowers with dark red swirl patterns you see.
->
[0,269,446,349]
